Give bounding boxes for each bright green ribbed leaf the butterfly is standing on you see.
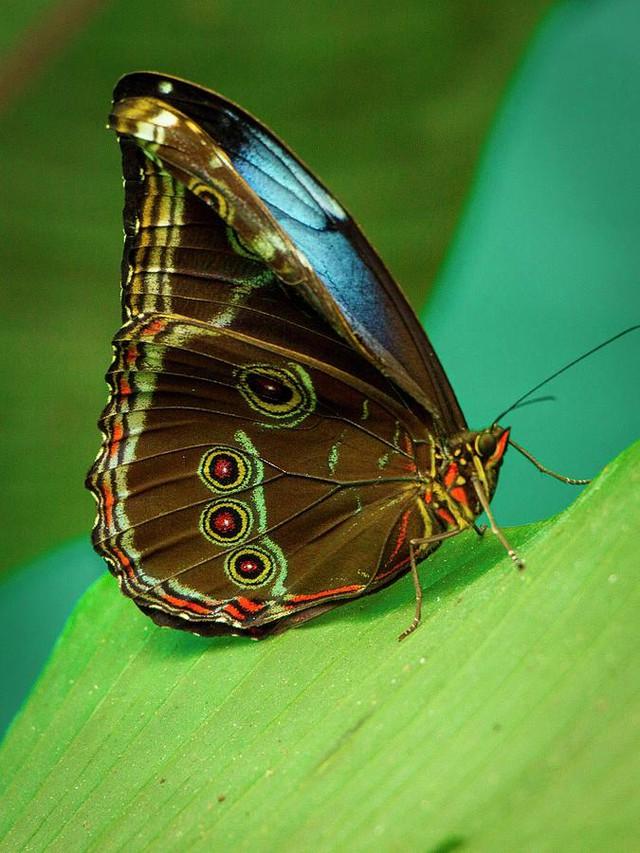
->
[0,443,640,851]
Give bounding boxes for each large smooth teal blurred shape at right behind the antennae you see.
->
[423,0,640,524]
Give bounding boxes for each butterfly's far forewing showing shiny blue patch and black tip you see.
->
[114,73,466,434]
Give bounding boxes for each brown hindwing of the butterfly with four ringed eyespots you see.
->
[89,315,430,633]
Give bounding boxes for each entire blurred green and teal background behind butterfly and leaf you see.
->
[0,0,640,732]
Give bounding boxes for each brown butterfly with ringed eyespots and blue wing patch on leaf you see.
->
[87,73,521,638]
